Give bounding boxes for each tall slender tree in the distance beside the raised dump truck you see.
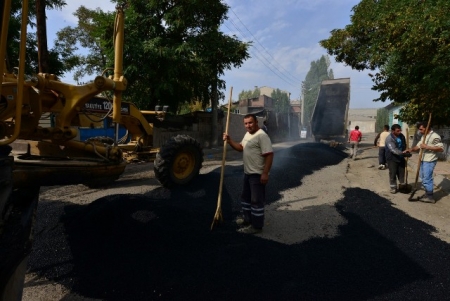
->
[302,55,334,127]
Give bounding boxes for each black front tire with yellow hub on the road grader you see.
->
[153,135,203,187]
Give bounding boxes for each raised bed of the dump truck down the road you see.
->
[311,78,350,142]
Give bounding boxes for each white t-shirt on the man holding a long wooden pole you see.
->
[241,129,273,175]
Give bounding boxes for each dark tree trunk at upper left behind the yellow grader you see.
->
[36,0,49,73]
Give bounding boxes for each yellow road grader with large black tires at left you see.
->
[0,0,203,300]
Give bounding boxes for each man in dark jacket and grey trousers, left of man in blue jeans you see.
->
[385,124,411,193]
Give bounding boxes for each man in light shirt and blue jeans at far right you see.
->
[409,123,444,204]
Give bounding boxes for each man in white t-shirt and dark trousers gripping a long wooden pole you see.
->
[223,114,273,234]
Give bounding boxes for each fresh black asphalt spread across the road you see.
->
[30,144,450,300]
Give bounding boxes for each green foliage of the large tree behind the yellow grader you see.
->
[56,0,249,112]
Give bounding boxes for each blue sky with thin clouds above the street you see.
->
[47,0,387,109]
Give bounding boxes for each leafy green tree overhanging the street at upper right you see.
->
[320,0,450,124]
